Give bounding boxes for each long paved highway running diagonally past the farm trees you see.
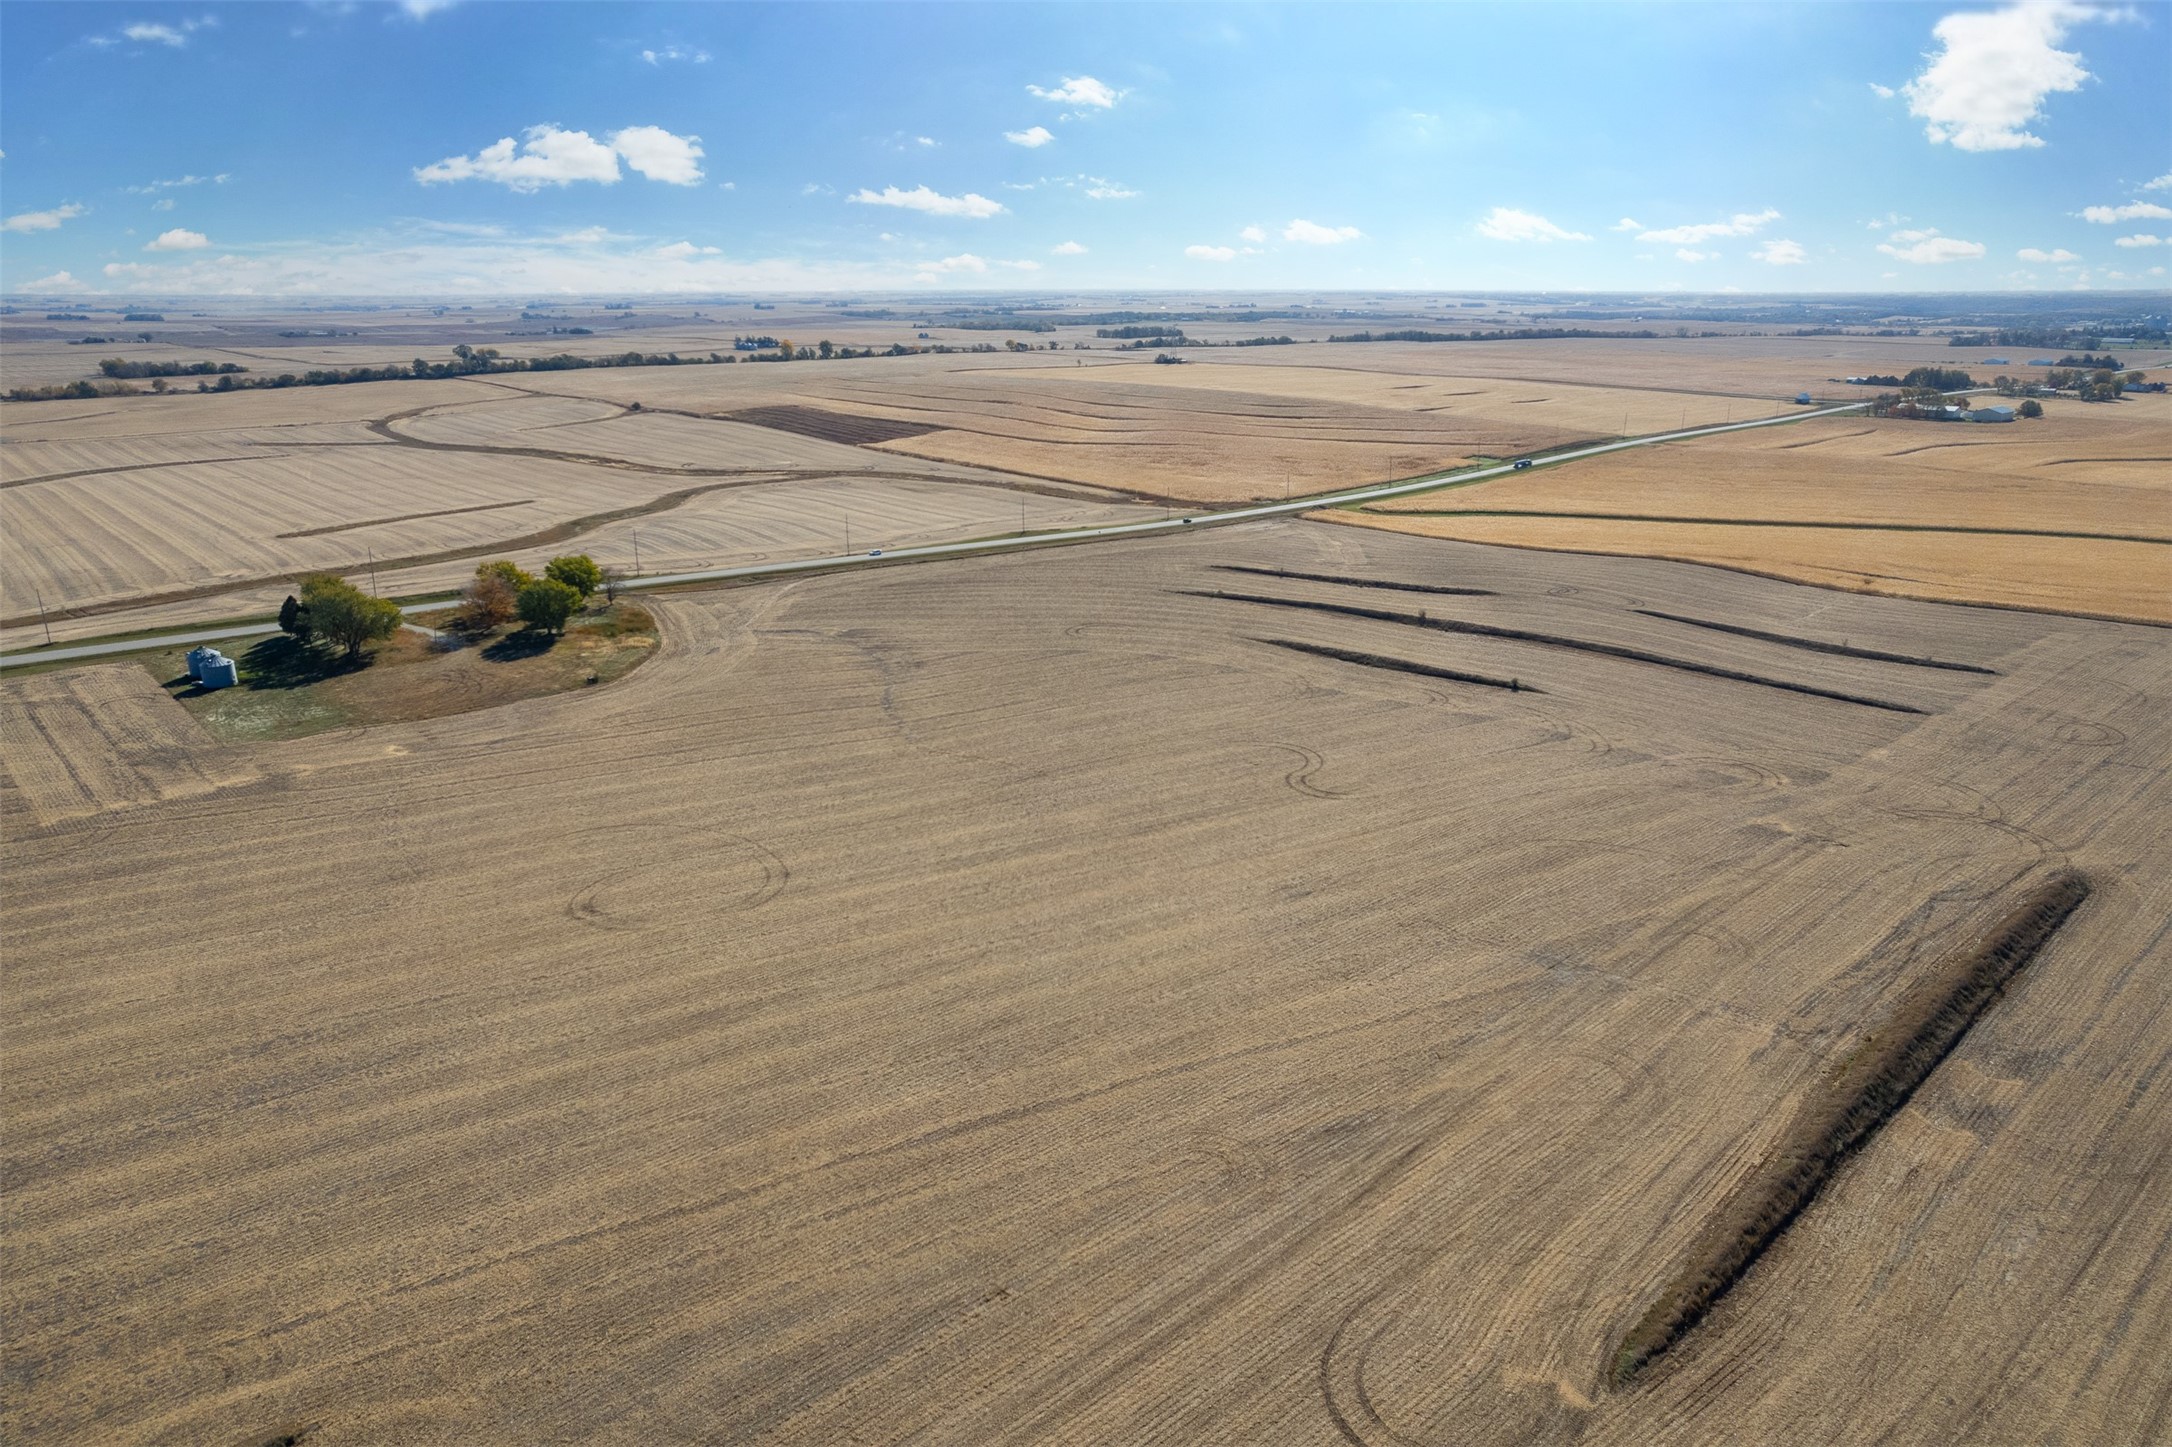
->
[0,393,1876,669]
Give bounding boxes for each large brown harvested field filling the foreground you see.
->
[0,524,2172,1447]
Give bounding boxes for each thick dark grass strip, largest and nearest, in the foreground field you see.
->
[1607,871,2089,1388]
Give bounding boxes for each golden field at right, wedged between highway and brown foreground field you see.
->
[1329,395,2172,621]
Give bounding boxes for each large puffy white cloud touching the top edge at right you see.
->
[1901,0,2116,150]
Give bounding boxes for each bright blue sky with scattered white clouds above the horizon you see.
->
[0,0,2172,295]
